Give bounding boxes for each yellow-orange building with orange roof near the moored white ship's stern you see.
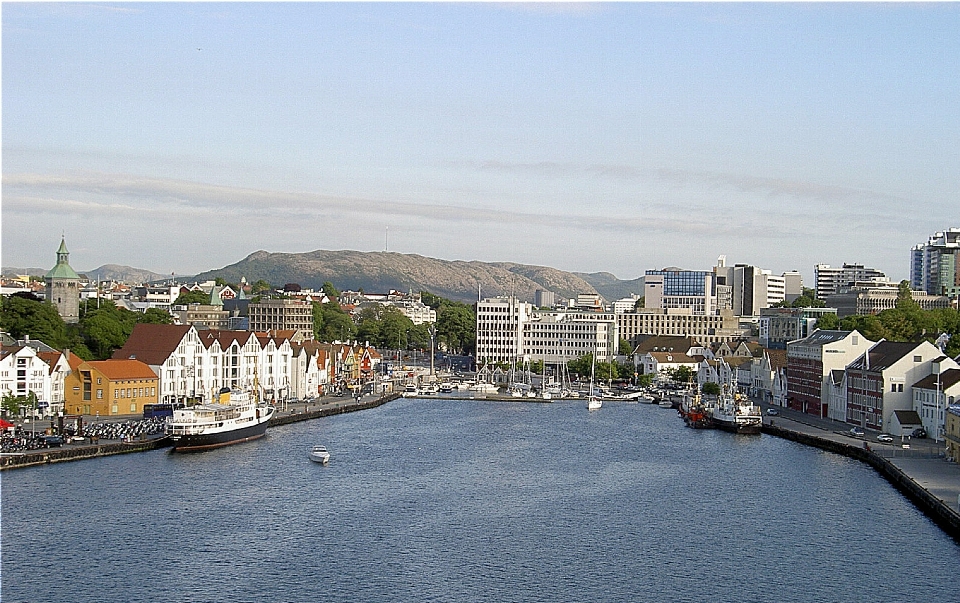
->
[64,356,159,416]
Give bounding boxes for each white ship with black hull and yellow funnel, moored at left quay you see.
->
[164,387,276,452]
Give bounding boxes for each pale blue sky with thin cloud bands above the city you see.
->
[0,2,960,286]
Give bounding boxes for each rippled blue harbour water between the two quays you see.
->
[0,399,960,603]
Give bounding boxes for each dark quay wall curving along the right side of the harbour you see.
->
[763,424,960,541]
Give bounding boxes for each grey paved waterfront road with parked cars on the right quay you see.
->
[762,404,960,511]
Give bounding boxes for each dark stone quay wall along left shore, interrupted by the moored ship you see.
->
[0,394,400,471]
